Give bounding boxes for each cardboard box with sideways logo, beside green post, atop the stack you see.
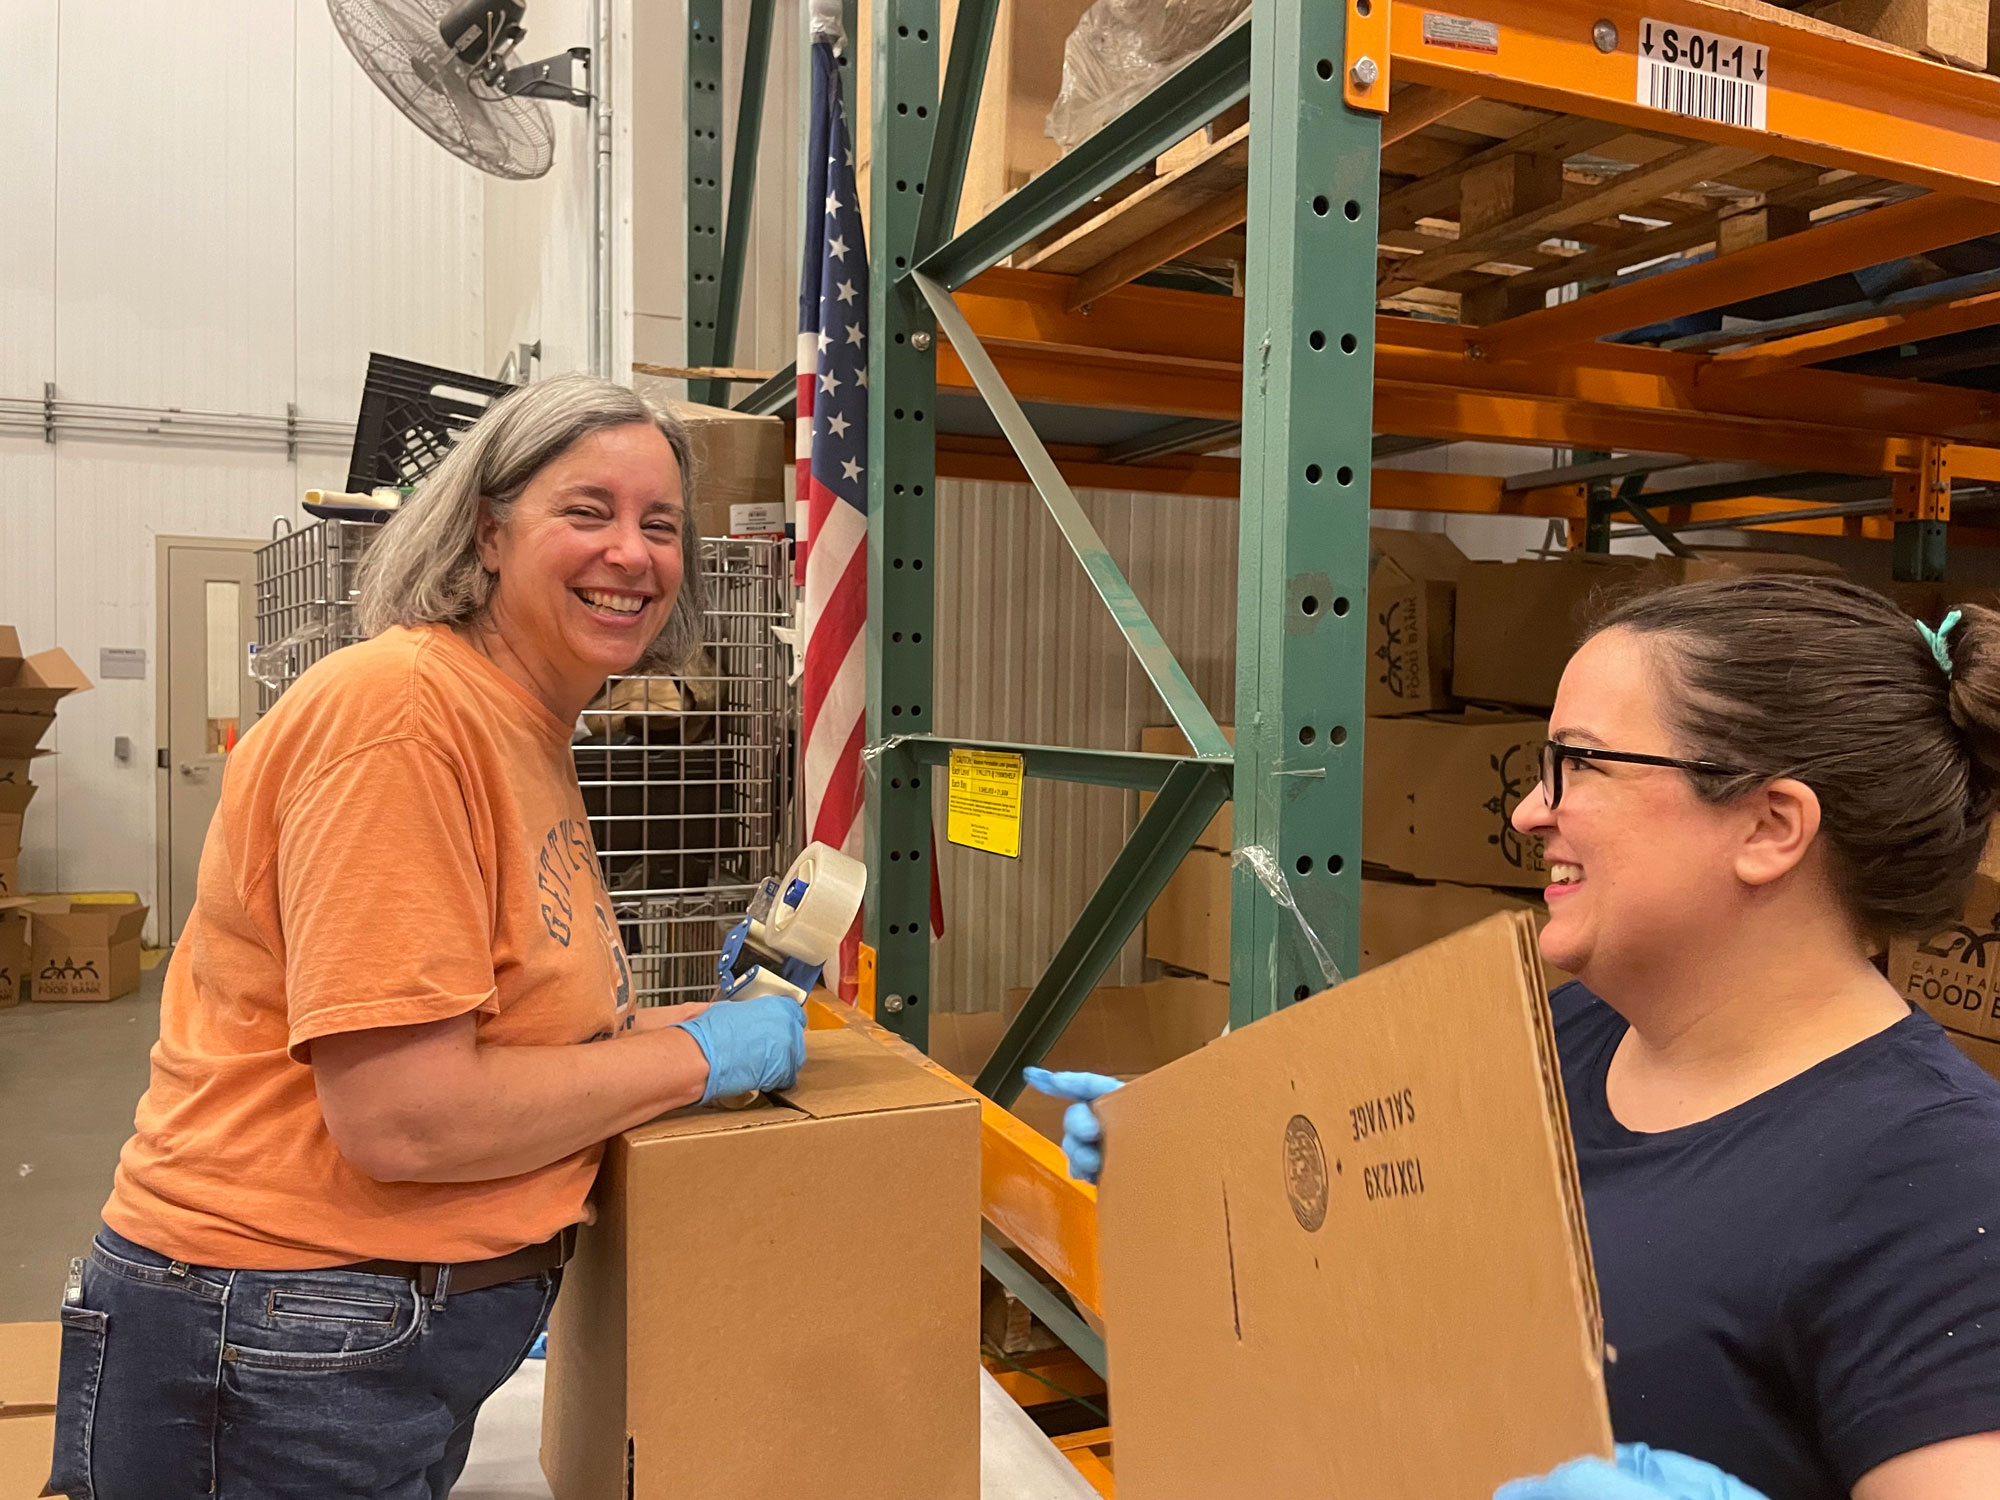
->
[1368,526,1468,714]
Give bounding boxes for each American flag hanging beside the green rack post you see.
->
[794,26,944,1000]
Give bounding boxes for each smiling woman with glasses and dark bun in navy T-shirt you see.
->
[1040,576,2000,1500]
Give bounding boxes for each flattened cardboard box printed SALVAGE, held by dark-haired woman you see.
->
[1098,914,1612,1500]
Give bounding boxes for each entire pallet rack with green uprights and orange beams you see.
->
[702,0,2000,1384]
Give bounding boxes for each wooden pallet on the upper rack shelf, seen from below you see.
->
[984,84,1942,334]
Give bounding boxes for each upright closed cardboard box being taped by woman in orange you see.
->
[542,1032,980,1500]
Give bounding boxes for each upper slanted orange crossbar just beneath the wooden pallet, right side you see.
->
[1468,194,2000,360]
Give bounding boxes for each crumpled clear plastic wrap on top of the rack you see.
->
[1046,0,1250,154]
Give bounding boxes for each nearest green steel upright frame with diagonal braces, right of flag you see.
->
[844,0,1380,1104]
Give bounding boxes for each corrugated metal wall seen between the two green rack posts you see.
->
[932,482,1236,1010]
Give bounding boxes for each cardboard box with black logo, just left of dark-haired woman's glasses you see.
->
[1362,712,1548,890]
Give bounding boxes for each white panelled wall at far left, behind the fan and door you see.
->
[0,0,498,936]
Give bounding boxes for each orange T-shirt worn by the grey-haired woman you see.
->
[104,626,632,1270]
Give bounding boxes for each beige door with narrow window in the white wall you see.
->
[158,536,262,942]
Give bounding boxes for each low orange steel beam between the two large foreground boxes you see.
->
[806,1000,1104,1318]
